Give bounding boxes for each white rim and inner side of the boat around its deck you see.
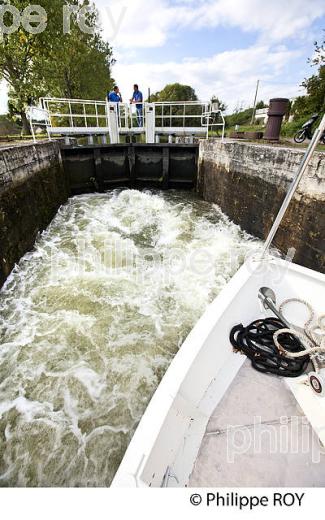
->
[112,259,325,487]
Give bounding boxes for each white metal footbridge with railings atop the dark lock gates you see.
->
[28,97,225,144]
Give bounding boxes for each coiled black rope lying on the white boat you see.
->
[230,318,309,377]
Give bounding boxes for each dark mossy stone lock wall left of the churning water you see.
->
[0,142,69,287]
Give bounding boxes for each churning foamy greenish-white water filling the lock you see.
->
[0,190,258,486]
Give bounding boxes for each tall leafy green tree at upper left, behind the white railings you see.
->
[0,0,112,133]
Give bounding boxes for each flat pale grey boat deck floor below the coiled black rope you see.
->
[189,361,325,487]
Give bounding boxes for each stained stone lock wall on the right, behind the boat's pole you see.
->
[198,140,325,273]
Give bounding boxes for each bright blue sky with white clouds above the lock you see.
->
[0,0,325,112]
